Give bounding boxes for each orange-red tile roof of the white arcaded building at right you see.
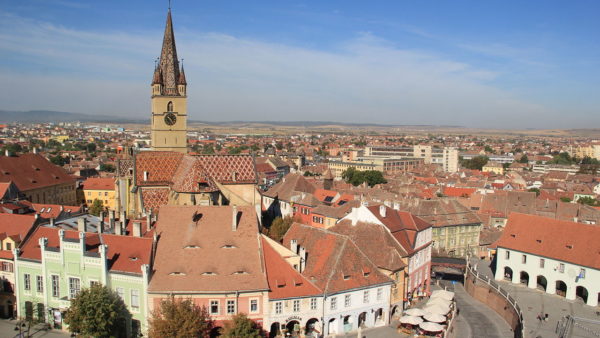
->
[496,213,600,269]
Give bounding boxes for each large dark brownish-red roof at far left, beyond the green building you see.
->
[0,154,75,191]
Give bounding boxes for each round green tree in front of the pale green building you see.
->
[65,284,131,338]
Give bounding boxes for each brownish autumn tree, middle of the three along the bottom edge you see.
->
[148,296,214,337]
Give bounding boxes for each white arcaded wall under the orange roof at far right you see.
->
[494,247,600,306]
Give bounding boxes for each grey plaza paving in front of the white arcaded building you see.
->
[475,260,600,338]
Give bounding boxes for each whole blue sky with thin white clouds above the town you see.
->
[0,0,600,129]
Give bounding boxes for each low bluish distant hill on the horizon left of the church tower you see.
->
[0,110,139,123]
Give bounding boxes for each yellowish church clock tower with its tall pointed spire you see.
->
[151,8,187,153]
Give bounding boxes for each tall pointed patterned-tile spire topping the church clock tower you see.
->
[159,8,179,96]
